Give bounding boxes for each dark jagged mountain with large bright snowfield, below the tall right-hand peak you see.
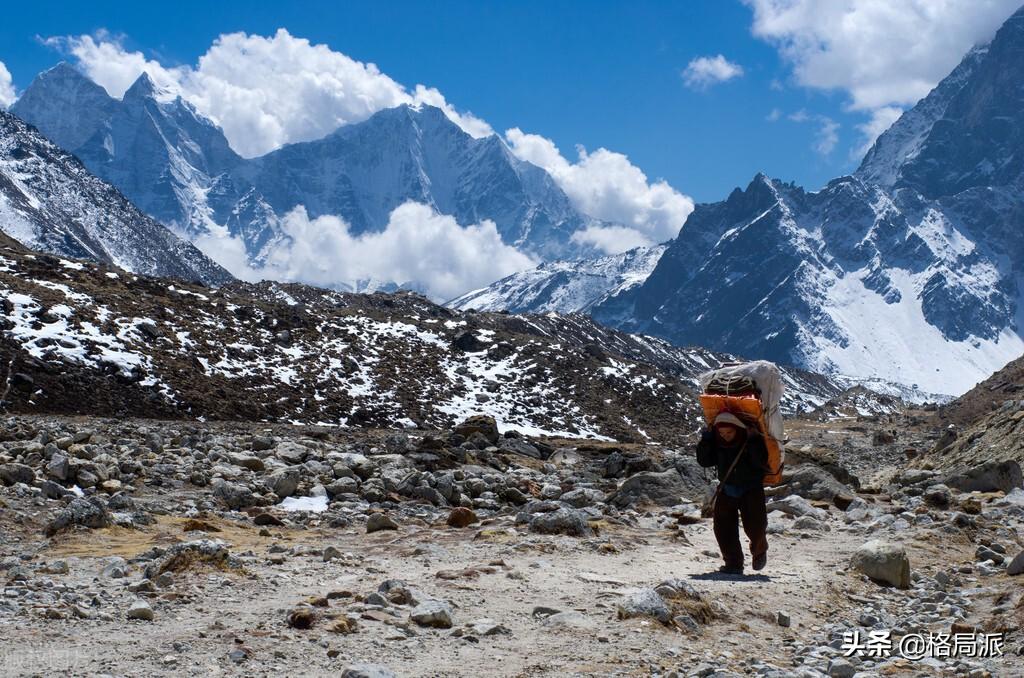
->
[593,166,1024,394]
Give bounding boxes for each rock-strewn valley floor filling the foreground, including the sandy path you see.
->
[0,412,1024,676]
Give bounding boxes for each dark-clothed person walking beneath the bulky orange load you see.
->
[697,412,768,575]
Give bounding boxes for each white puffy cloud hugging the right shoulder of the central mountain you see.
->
[505,128,693,254]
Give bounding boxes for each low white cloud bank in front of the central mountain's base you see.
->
[196,202,538,300]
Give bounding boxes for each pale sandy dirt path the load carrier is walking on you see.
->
[3,501,1003,676]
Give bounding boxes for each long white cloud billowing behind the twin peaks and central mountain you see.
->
[46,29,492,158]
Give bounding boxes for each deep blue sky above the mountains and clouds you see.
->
[0,0,1009,202]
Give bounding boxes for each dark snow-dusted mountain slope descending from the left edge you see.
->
[0,111,231,285]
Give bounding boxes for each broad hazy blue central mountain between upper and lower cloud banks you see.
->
[239,105,591,258]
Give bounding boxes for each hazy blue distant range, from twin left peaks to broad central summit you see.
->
[11,69,595,264]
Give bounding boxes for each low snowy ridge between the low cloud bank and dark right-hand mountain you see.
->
[445,245,666,313]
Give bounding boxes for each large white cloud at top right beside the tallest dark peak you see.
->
[745,0,1021,111]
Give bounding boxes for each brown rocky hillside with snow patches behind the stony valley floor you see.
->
[0,237,887,444]
